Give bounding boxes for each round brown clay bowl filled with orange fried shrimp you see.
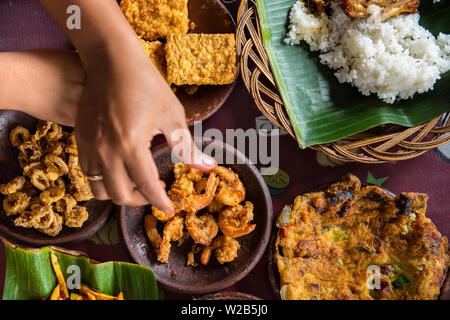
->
[120,141,272,294]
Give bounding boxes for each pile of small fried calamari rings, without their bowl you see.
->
[0,121,93,236]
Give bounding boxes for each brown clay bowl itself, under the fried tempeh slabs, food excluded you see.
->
[176,0,236,126]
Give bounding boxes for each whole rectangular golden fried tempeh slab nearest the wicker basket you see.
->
[165,33,237,85]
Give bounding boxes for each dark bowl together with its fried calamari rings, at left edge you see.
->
[0,111,112,246]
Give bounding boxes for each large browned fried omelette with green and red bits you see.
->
[275,175,449,300]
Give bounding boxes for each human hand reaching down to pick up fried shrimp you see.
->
[75,38,216,212]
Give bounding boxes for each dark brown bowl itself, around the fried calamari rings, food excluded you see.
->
[0,111,113,247]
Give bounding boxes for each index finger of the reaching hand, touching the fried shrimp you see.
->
[125,147,174,213]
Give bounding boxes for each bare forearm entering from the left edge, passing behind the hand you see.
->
[0,49,85,125]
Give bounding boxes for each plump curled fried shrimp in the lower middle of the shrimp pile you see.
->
[185,211,219,246]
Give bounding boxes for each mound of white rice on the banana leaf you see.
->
[285,1,450,103]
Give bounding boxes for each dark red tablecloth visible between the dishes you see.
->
[0,0,450,299]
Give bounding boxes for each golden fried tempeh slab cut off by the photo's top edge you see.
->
[120,0,189,40]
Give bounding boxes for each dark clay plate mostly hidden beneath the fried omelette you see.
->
[267,185,450,300]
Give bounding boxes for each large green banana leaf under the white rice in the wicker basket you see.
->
[256,0,450,148]
